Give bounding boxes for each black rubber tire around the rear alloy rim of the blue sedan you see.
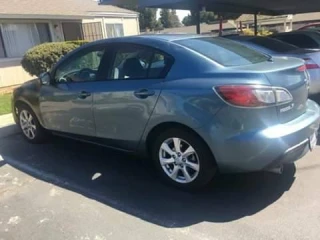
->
[151,129,217,190]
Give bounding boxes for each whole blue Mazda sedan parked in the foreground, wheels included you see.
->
[12,35,320,188]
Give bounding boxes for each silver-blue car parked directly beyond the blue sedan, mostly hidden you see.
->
[226,36,320,94]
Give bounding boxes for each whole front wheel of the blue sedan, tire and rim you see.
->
[17,104,47,143]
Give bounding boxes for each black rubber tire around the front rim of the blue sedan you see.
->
[17,104,46,143]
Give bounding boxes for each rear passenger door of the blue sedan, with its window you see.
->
[93,44,172,150]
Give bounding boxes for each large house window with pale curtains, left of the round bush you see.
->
[0,23,51,57]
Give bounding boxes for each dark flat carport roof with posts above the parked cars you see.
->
[100,0,320,35]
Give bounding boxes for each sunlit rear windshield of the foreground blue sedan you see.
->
[176,37,269,66]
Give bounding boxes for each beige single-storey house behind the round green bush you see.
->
[0,0,140,88]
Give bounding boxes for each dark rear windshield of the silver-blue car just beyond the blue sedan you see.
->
[249,37,298,53]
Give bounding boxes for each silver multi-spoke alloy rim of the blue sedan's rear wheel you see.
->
[159,138,200,183]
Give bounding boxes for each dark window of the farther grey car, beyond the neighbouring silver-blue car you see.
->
[276,34,319,48]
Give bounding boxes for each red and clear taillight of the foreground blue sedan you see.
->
[214,85,292,107]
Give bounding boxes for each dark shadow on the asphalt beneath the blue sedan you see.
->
[0,135,295,228]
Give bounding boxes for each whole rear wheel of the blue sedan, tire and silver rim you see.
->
[151,128,217,190]
